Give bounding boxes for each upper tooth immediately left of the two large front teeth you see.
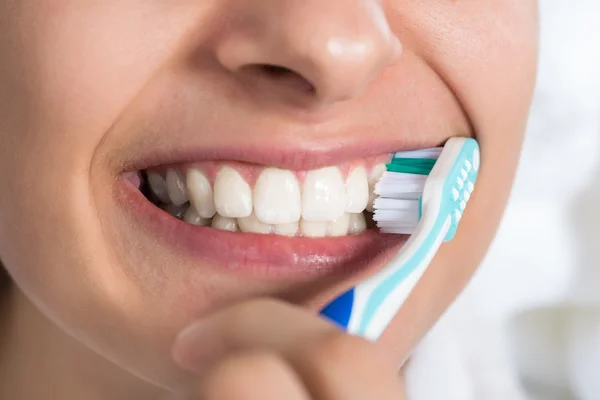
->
[214,167,252,219]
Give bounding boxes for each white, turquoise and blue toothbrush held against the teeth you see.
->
[321,138,480,341]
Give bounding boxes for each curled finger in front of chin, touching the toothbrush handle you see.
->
[174,300,401,400]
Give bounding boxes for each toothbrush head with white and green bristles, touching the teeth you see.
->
[373,138,480,241]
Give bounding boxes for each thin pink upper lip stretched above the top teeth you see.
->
[122,135,440,171]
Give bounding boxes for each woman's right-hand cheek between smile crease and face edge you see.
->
[390,0,538,136]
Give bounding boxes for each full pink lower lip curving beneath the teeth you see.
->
[116,179,408,278]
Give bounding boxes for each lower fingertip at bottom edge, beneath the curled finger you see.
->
[185,351,310,400]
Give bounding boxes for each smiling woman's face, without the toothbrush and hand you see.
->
[0,0,537,386]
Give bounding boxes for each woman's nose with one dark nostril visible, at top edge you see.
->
[216,0,402,105]
